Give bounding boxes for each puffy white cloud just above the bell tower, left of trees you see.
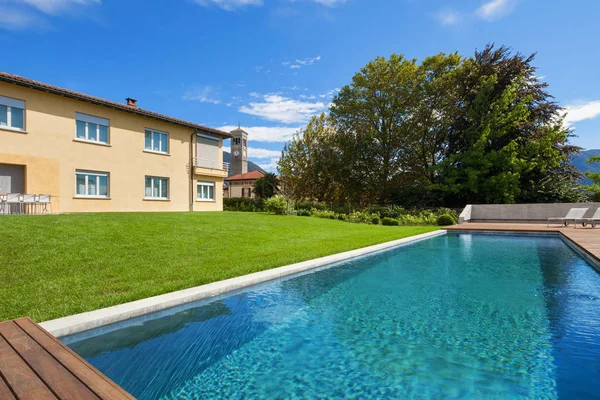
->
[239,94,326,124]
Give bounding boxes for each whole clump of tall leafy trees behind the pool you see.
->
[280,45,582,206]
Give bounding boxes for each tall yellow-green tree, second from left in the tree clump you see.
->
[330,54,418,202]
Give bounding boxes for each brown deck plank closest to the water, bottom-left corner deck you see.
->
[15,318,134,400]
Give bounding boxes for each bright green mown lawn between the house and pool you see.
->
[0,212,437,321]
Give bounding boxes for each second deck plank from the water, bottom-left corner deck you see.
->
[0,321,100,400]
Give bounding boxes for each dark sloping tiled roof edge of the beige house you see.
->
[0,71,231,138]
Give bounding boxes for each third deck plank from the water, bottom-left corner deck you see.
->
[0,332,56,400]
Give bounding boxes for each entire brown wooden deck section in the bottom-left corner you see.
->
[0,318,134,400]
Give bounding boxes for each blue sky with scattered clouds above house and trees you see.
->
[0,0,600,170]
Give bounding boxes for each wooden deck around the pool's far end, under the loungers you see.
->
[447,222,600,265]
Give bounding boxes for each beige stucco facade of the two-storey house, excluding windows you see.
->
[0,82,227,213]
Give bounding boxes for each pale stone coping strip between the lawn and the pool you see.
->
[39,229,447,338]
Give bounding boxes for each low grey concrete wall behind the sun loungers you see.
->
[460,203,600,223]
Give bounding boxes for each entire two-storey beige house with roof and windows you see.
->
[0,72,231,213]
